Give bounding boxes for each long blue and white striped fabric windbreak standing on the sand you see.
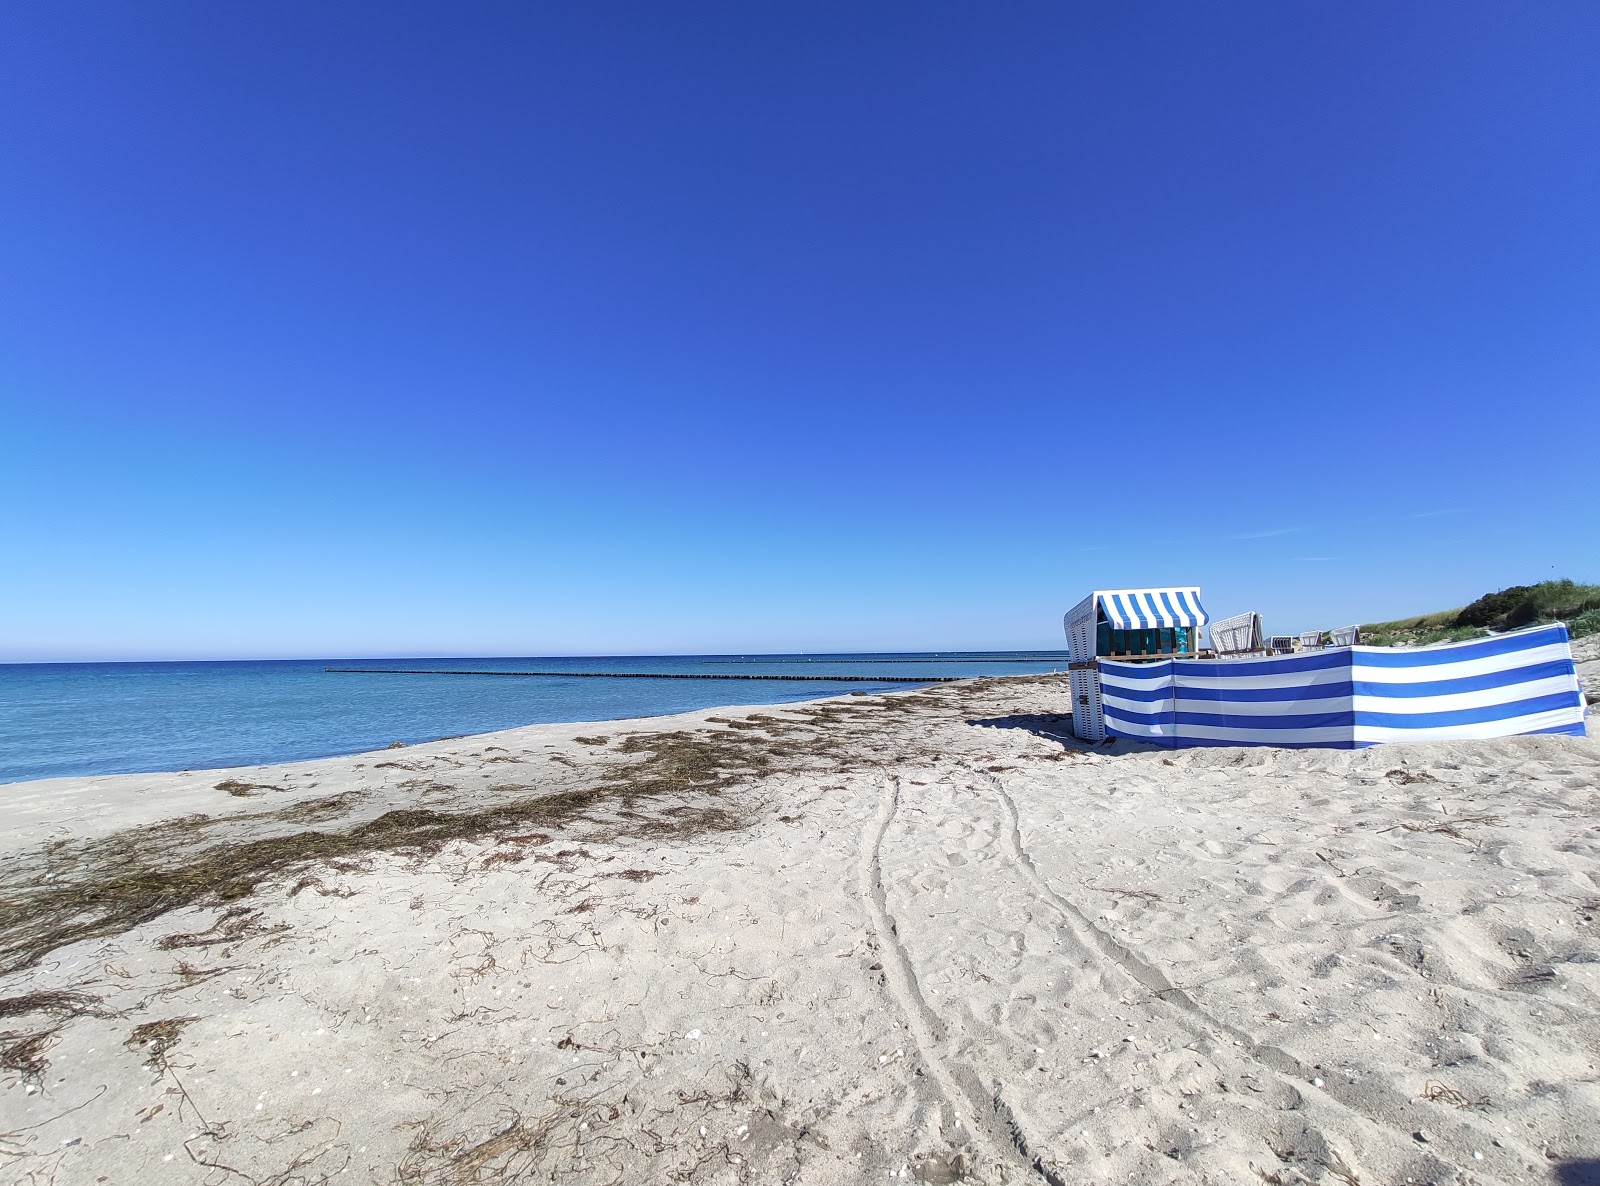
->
[1099,624,1584,749]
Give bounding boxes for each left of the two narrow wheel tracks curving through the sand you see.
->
[858,778,1066,1186]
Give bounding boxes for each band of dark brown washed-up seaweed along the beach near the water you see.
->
[0,682,982,973]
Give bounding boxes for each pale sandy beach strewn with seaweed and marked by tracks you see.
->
[0,675,1600,1186]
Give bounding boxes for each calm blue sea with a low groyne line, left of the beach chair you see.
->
[0,651,1067,783]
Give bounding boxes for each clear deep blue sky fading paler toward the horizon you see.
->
[0,3,1600,661]
